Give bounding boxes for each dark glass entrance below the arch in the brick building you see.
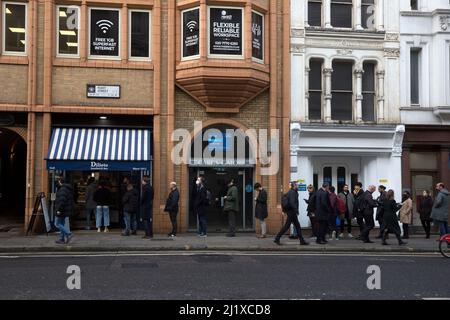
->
[189,167,254,232]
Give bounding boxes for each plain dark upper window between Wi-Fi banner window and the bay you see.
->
[129,10,151,59]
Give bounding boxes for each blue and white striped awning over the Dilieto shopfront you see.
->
[47,128,152,169]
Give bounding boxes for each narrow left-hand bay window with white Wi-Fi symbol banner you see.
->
[181,8,200,60]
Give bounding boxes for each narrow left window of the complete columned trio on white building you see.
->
[308,60,323,120]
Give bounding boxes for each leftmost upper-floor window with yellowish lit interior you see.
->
[2,2,27,54]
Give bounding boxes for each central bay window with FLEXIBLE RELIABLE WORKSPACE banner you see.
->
[208,7,244,59]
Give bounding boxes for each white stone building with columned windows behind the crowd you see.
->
[291,0,405,226]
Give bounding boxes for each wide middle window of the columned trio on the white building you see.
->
[331,61,353,121]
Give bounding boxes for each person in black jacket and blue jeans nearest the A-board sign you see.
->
[55,179,75,244]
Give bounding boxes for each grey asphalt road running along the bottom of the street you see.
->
[0,253,450,300]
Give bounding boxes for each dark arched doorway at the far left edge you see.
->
[0,127,27,224]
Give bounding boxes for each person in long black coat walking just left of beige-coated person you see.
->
[381,190,407,246]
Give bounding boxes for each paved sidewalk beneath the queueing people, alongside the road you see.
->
[0,231,438,253]
